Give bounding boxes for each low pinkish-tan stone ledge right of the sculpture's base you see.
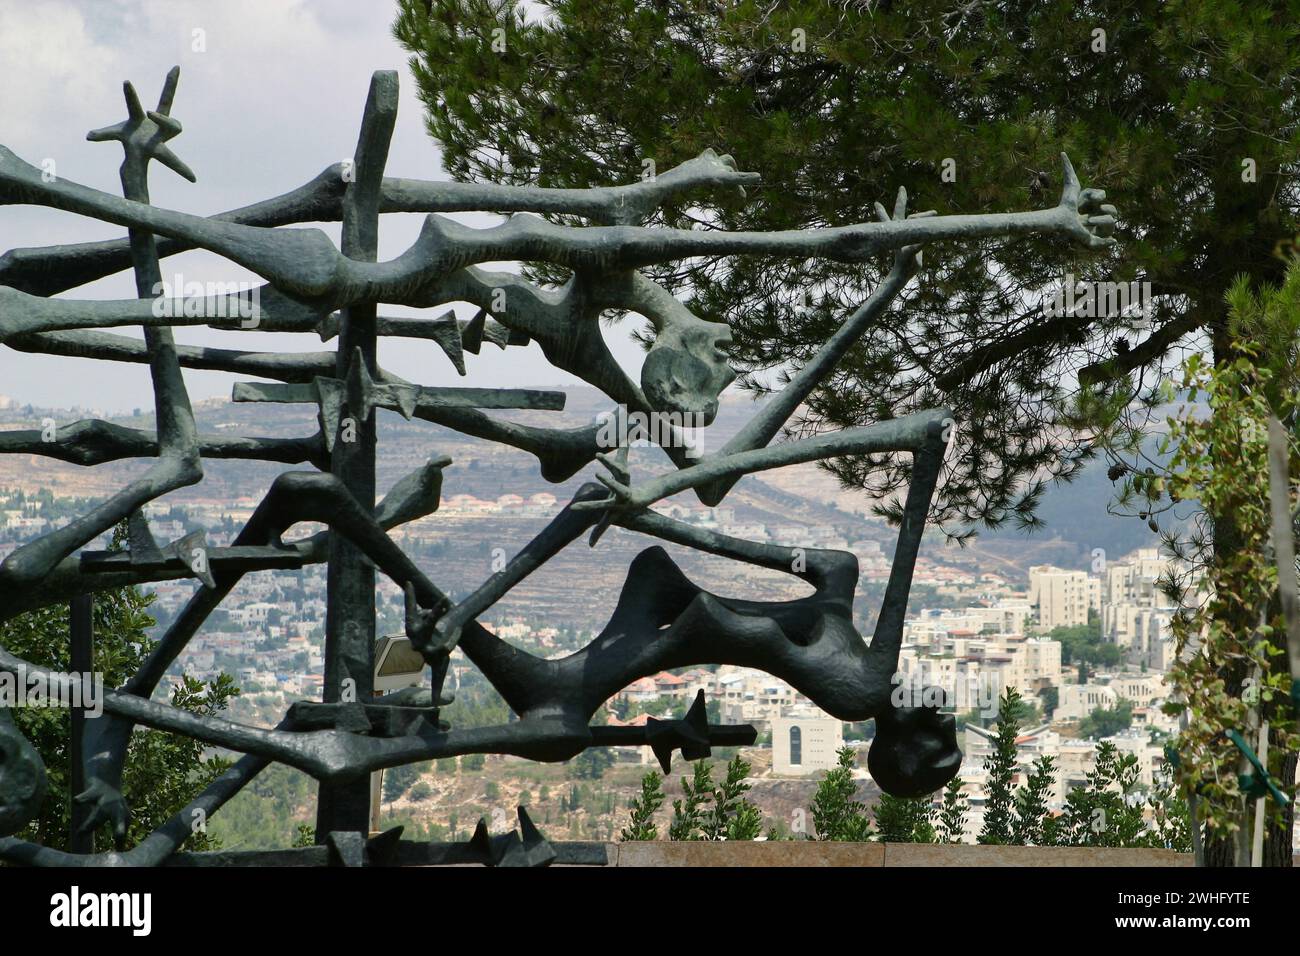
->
[607,840,1192,868]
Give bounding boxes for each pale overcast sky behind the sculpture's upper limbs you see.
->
[0,0,642,412]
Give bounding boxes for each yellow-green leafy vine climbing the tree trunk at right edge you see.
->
[1164,295,1300,840]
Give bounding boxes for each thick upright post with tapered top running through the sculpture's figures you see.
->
[316,70,398,843]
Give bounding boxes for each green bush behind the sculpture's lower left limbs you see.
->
[0,567,239,851]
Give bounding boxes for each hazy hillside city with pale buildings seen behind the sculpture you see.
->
[0,389,1258,847]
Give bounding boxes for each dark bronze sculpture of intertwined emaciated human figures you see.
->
[0,63,1114,866]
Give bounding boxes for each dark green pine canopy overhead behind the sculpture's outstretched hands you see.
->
[394,0,1300,546]
